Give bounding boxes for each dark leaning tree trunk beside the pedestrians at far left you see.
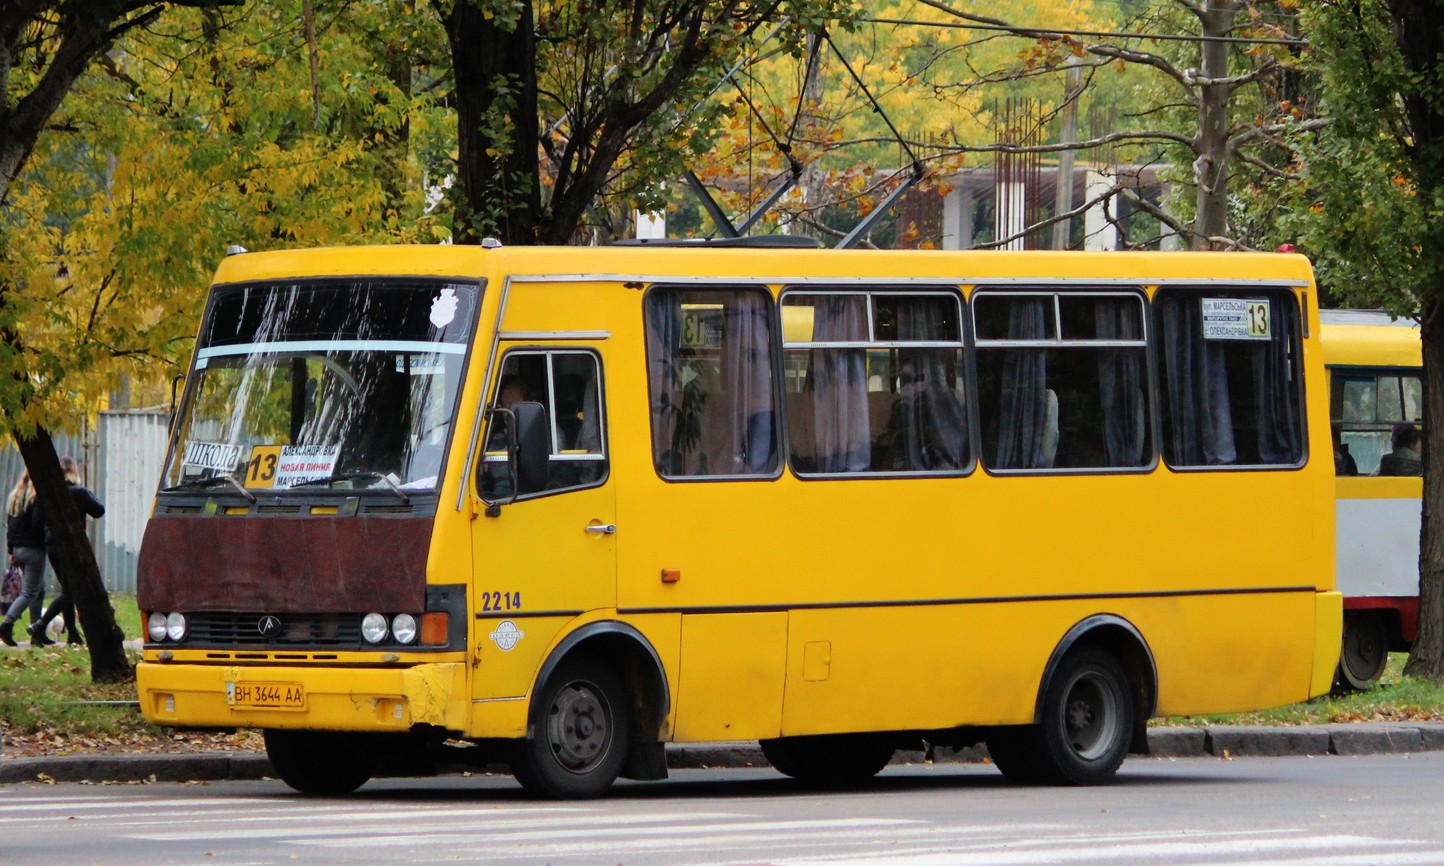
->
[14,427,136,683]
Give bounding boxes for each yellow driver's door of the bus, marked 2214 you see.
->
[471,344,617,710]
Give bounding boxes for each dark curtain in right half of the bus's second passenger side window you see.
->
[892,297,967,472]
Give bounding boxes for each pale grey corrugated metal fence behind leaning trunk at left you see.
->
[0,411,170,592]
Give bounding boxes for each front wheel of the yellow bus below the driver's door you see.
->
[511,658,631,800]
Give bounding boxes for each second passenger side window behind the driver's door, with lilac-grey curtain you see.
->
[781,290,972,475]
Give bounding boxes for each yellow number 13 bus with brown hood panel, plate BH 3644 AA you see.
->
[139,241,1341,798]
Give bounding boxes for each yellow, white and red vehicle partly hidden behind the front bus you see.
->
[1320,310,1424,691]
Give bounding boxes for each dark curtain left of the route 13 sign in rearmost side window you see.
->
[1162,296,1239,466]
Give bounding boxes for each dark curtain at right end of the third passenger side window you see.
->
[1093,300,1148,466]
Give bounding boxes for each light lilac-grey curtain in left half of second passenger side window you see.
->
[809,294,872,472]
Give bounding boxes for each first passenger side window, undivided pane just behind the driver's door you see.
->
[643,286,780,478]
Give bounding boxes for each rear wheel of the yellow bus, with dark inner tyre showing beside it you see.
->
[988,647,1135,785]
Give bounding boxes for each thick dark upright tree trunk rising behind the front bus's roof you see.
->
[446,0,542,244]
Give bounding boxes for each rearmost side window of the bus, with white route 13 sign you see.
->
[1154,289,1304,466]
